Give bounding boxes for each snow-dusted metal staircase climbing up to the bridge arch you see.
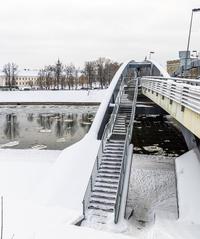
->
[82,79,137,225]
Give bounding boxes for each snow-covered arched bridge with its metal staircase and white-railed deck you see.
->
[37,60,200,230]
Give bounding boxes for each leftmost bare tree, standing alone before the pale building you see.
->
[3,62,18,89]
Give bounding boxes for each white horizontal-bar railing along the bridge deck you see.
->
[140,77,200,114]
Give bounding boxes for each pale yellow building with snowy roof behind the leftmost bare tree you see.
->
[0,69,39,88]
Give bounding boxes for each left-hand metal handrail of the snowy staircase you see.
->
[82,77,124,218]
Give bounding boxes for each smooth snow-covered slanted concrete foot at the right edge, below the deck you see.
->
[176,149,200,224]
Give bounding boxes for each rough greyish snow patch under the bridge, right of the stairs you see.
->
[127,154,177,225]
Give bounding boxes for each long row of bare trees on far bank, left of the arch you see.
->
[37,58,120,90]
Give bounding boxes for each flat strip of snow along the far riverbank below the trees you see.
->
[0,89,107,103]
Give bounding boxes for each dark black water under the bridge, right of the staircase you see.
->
[133,115,187,156]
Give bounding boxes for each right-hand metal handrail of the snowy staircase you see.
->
[114,78,138,223]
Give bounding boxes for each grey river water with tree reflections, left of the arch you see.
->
[0,106,98,150]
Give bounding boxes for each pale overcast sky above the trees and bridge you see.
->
[0,0,200,68]
